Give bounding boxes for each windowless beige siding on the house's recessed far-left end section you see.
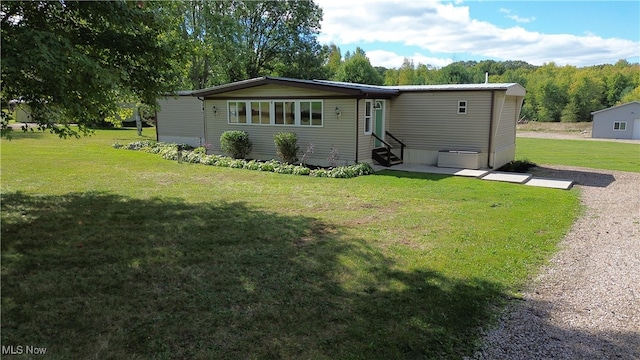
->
[157,96,204,146]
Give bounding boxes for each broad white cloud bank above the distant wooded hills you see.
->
[317,0,640,67]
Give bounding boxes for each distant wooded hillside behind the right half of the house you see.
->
[384,59,640,122]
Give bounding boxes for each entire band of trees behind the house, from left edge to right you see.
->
[0,0,640,136]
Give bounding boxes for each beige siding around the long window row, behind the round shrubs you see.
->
[205,97,356,166]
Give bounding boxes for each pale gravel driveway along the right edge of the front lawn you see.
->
[473,134,640,359]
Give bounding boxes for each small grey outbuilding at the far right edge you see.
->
[591,101,640,140]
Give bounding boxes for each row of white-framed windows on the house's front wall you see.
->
[227,100,323,127]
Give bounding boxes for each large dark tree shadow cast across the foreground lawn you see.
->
[1,193,503,359]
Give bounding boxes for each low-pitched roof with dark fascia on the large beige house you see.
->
[191,76,526,98]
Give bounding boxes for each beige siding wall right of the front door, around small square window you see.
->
[387,91,491,152]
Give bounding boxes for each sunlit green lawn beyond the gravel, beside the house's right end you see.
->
[516,137,640,172]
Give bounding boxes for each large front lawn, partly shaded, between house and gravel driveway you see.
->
[1,129,579,359]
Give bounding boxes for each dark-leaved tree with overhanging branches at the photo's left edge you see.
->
[0,0,179,137]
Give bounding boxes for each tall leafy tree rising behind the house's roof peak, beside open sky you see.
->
[209,1,323,82]
